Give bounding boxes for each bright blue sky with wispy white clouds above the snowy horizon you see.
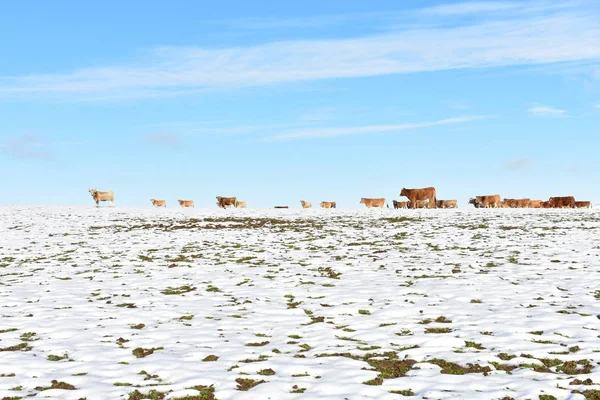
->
[0,0,600,207]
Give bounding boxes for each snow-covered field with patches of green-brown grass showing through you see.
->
[0,207,600,400]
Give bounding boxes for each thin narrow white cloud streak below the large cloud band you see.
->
[265,115,488,141]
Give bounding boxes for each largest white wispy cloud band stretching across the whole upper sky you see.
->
[0,2,600,100]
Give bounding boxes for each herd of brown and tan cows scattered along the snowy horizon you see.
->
[90,187,592,208]
